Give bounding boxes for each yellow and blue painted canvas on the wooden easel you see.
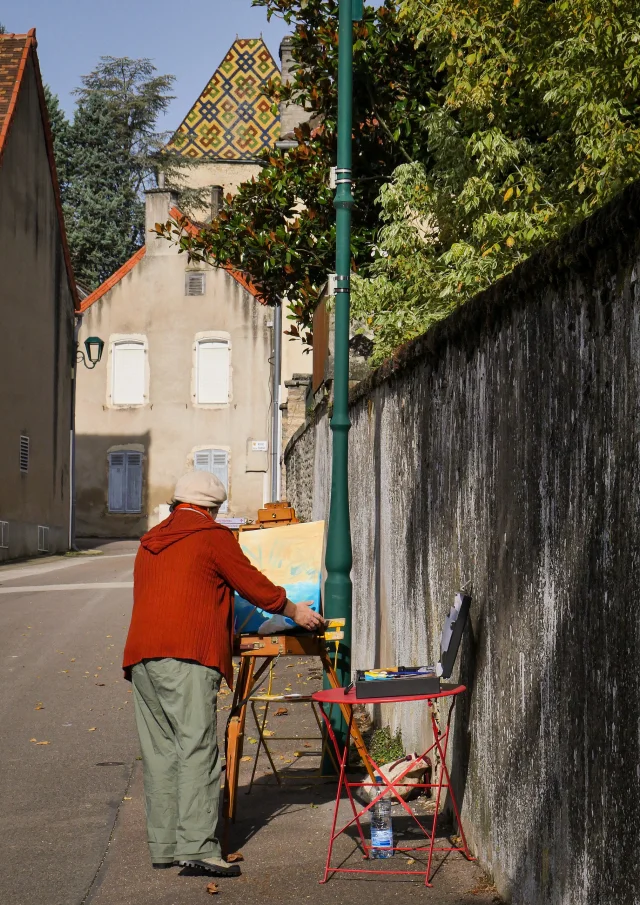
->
[234,522,324,634]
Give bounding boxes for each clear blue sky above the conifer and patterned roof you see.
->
[0,0,289,130]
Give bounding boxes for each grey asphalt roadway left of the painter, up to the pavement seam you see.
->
[0,543,138,905]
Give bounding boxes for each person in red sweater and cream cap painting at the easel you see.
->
[123,471,323,877]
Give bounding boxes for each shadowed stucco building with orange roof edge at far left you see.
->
[0,29,79,561]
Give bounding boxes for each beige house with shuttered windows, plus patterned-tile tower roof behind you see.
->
[76,39,308,537]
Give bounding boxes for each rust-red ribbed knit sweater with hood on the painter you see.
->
[122,503,287,686]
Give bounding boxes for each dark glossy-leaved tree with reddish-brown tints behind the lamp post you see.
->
[161,0,437,341]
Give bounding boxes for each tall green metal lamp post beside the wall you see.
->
[324,0,363,744]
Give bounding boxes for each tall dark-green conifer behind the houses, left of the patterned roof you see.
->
[45,57,202,289]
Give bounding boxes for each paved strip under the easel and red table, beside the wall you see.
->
[85,658,500,905]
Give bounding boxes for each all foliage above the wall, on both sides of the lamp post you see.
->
[158,0,640,359]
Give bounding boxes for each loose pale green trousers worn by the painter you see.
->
[131,657,221,864]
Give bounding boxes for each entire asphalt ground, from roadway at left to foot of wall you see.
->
[0,542,496,905]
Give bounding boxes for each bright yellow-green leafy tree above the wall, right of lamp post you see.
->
[354,0,640,358]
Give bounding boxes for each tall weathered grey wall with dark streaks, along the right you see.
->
[285,185,640,905]
